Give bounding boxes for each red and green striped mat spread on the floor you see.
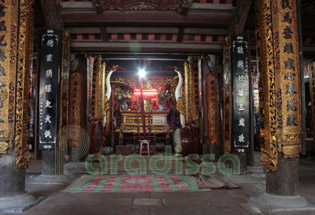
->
[64,175,210,192]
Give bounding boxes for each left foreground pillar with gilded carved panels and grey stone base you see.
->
[0,0,35,212]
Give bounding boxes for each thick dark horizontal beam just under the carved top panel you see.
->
[62,11,232,27]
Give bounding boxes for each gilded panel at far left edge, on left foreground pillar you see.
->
[0,1,18,148]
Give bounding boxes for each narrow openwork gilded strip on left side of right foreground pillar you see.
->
[256,0,278,171]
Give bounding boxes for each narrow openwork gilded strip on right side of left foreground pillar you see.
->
[15,0,33,168]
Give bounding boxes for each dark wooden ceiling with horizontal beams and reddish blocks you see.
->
[38,0,251,55]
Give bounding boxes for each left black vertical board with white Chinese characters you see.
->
[38,30,60,150]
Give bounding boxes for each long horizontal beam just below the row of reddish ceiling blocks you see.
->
[71,42,223,54]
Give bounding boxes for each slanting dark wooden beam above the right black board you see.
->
[230,0,253,35]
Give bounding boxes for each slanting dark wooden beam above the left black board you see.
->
[40,0,63,29]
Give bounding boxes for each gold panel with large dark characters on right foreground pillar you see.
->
[272,0,302,158]
